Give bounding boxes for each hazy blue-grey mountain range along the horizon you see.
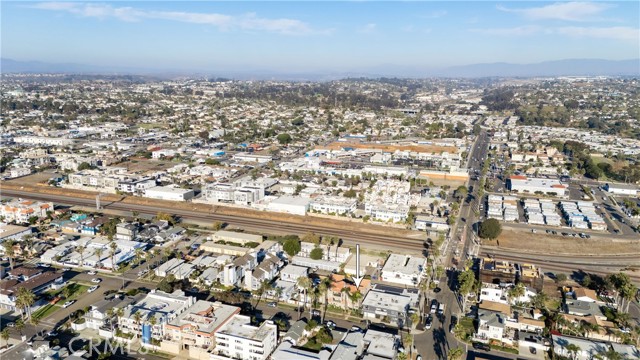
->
[0,58,640,80]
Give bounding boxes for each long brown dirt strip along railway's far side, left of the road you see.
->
[2,189,425,251]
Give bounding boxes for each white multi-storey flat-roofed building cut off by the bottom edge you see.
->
[211,314,278,360]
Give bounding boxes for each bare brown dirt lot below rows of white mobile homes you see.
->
[482,229,640,255]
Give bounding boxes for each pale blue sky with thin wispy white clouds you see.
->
[0,1,640,72]
